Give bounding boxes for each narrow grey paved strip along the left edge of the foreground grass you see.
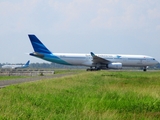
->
[0,73,75,88]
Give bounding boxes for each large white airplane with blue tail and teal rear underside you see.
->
[28,34,159,71]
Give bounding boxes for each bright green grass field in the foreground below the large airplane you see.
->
[0,71,160,120]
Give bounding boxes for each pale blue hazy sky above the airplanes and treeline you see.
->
[0,0,160,63]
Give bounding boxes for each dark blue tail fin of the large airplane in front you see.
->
[28,35,51,54]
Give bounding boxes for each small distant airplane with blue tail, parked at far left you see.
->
[2,60,30,69]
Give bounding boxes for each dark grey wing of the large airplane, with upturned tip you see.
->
[91,52,111,64]
